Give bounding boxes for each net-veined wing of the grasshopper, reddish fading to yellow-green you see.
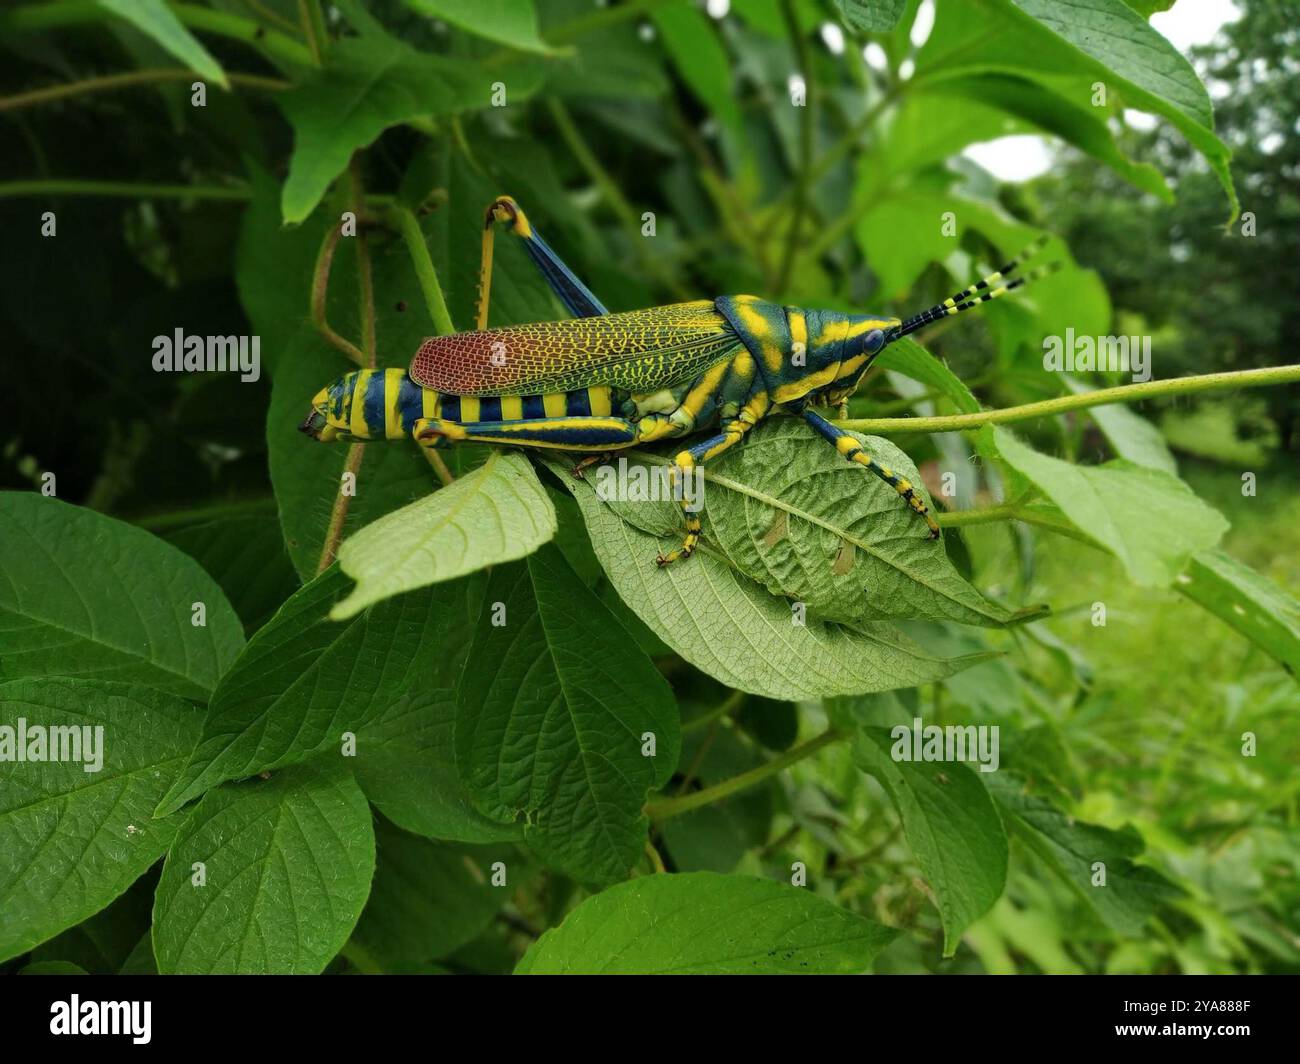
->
[410,299,741,395]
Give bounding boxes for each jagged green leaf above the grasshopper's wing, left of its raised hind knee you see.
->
[276,33,538,225]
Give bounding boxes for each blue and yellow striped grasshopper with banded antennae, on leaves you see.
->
[300,196,1056,565]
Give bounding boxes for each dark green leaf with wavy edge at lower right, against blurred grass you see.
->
[988,771,1180,935]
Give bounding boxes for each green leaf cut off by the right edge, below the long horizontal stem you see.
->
[1178,550,1300,676]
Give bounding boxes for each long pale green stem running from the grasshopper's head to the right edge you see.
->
[840,366,1300,432]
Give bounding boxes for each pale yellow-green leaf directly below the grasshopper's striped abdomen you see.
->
[330,450,556,620]
